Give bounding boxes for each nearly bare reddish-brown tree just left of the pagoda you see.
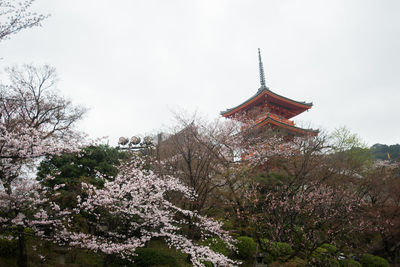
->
[153,115,291,219]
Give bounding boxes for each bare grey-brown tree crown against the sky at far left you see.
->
[0,65,86,138]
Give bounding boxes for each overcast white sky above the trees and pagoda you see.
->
[0,0,400,145]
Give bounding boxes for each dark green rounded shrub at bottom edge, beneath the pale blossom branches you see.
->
[133,248,179,267]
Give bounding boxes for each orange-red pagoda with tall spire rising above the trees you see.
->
[221,49,318,136]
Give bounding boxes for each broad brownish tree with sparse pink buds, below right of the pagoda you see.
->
[238,135,371,257]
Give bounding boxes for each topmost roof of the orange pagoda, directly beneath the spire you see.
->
[221,86,313,117]
